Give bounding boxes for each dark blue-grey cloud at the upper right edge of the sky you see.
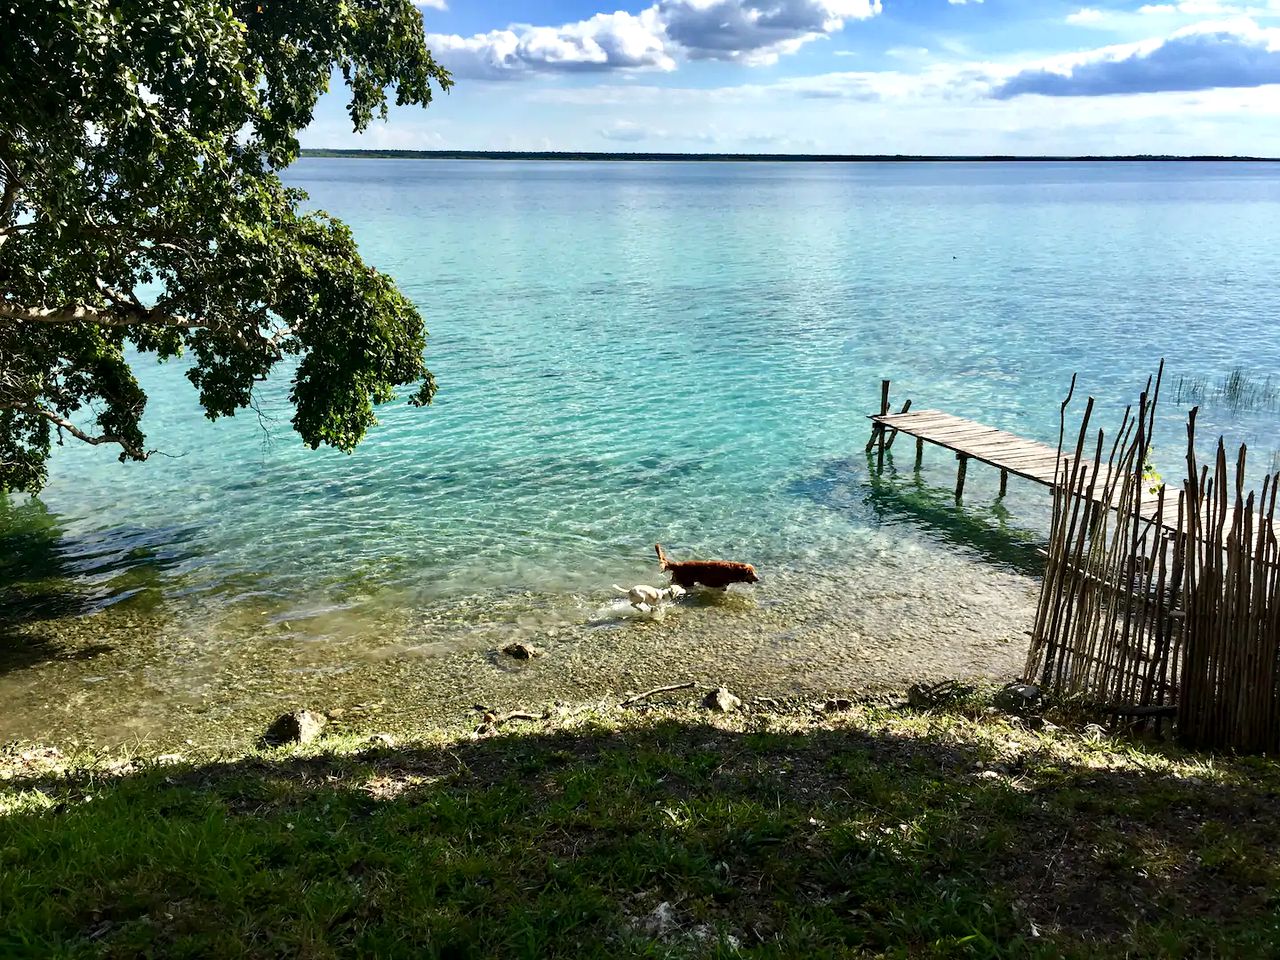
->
[992,20,1280,100]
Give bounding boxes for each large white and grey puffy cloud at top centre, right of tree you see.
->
[428,0,881,79]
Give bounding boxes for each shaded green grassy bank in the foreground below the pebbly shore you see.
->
[0,698,1280,957]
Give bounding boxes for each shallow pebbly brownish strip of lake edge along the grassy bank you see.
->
[0,573,1034,749]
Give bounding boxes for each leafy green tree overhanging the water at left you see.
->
[0,0,452,490]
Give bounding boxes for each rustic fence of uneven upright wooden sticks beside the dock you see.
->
[1027,366,1280,751]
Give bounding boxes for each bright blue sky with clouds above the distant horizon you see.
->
[302,0,1280,156]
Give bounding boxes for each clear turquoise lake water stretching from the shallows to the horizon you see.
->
[0,159,1280,735]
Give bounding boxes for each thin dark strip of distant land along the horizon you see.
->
[302,147,1280,164]
